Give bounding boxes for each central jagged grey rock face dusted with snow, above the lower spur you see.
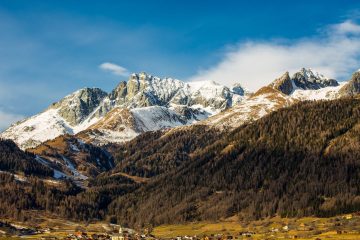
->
[99,72,245,110]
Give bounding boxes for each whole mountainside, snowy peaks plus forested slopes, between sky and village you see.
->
[0,68,360,238]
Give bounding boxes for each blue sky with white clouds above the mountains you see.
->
[0,0,360,129]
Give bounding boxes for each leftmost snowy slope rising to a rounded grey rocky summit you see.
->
[1,88,106,149]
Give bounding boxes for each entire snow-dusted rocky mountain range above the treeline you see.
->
[1,68,359,149]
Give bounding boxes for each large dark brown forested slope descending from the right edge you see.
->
[109,99,360,225]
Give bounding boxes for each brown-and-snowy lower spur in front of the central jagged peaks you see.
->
[76,106,210,145]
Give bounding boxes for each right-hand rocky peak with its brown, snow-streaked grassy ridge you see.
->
[198,68,351,129]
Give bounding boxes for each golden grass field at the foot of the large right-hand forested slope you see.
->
[153,215,360,240]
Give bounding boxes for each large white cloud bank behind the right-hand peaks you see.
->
[189,20,360,91]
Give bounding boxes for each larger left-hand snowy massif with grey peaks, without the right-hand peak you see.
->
[1,72,245,149]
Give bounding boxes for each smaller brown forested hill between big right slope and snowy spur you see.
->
[112,126,220,177]
